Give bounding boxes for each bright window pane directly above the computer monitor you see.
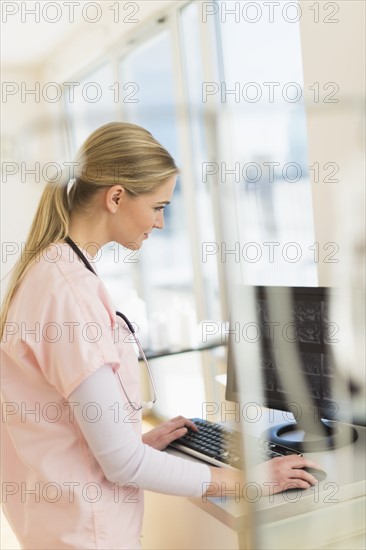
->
[214,2,317,286]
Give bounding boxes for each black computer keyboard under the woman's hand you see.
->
[170,418,301,469]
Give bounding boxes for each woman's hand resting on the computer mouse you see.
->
[250,455,321,496]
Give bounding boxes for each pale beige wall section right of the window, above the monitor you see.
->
[300,0,366,285]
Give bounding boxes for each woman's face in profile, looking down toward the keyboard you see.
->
[110,175,176,250]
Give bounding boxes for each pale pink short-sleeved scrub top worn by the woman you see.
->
[1,243,143,550]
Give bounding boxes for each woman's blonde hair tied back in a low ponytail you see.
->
[0,122,178,338]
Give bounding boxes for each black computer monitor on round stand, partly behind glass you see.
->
[226,286,364,452]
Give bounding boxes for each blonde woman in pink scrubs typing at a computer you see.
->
[1,123,315,550]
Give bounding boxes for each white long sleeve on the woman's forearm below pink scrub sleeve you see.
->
[70,365,210,497]
